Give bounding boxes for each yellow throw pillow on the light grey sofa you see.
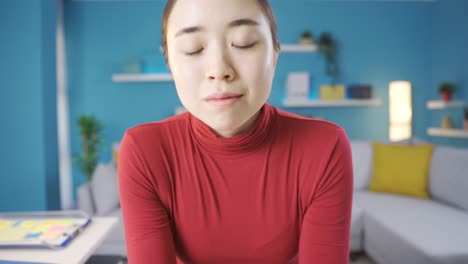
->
[369,142,434,199]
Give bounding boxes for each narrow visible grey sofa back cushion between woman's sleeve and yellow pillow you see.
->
[351,141,372,190]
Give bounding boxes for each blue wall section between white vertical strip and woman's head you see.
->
[65,1,180,199]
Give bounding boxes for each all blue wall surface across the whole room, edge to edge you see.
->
[0,0,468,211]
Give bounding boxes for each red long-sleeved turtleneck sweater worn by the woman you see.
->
[118,104,353,264]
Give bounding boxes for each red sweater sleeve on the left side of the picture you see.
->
[118,132,176,264]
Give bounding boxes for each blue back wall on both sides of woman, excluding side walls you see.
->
[65,1,438,198]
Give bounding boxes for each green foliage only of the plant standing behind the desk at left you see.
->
[74,115,103,182]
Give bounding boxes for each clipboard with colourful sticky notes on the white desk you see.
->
[0,210,91,249]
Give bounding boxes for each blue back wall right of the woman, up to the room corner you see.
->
[271,1,430,142]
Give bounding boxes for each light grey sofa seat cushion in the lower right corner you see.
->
[354,192,468,264]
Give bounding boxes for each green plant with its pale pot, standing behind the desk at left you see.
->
[74,115,102,214]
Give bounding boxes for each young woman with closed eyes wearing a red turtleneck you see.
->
[118,0,353,264]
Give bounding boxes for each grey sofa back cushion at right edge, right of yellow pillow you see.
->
[429,146,468,211]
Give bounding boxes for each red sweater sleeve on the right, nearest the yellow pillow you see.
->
[299,129,353,264]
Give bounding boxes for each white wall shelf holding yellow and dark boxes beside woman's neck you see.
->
[283,99,382,107]
